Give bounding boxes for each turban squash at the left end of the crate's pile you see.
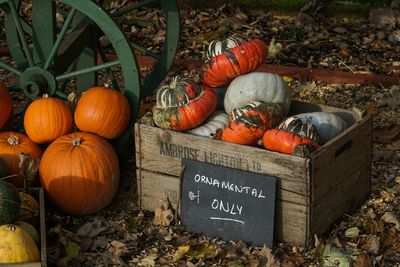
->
[153,76,217,131]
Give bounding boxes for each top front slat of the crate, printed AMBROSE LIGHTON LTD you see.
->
[135,124,309,195]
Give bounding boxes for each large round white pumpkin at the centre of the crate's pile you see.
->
[224,72,290,115]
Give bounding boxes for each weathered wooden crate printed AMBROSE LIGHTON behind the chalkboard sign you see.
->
[135,101,372,246]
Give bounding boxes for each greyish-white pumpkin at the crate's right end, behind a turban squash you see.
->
[296,111,347,144]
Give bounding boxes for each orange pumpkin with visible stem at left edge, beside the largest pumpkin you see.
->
[0,132,42,187]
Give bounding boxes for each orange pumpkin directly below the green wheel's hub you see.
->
[24,95,72,144]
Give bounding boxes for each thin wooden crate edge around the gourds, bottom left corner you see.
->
[0,187,47,267]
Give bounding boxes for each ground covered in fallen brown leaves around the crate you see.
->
[2,1,400,267]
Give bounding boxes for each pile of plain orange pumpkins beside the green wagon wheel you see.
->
[0,84,131,261]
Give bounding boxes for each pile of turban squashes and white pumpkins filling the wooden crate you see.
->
[153,36,347,157]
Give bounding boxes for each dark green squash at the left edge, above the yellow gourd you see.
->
[0,181,21,225]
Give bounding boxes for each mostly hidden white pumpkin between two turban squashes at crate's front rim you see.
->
[188,111,229,137]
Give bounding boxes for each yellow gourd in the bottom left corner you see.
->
[0,224,40,263]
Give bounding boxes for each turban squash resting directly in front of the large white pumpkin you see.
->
[221,101,282,146]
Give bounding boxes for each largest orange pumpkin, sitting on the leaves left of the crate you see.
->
[39,132,120,215]
